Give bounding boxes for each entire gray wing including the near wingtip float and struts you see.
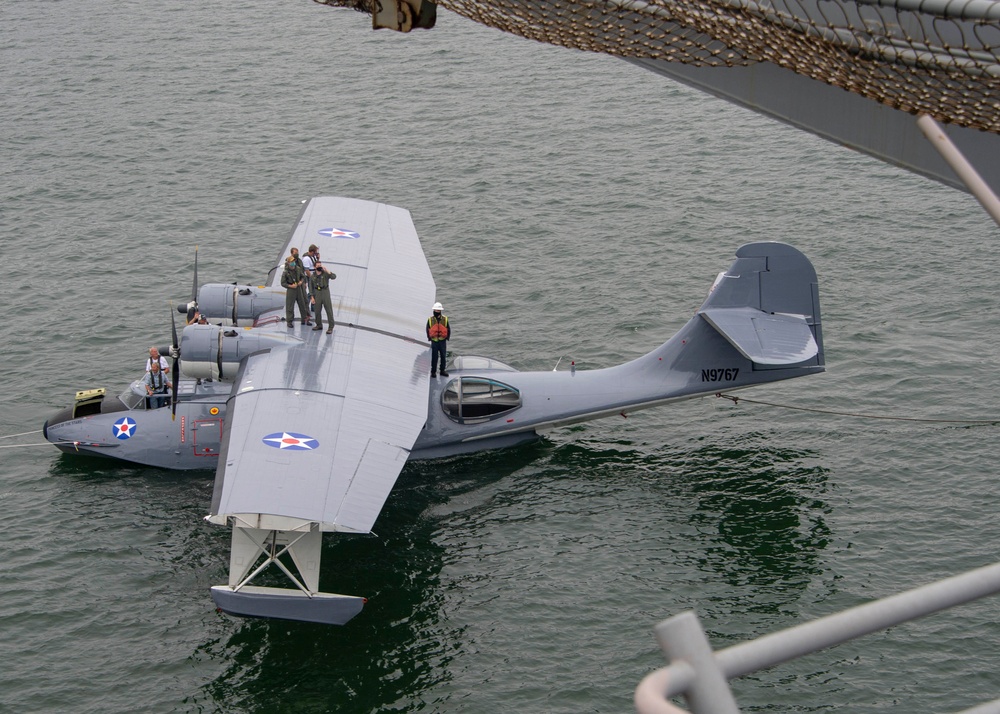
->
[208,197,435,624]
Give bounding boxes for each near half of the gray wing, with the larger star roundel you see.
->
[212,326,428,533]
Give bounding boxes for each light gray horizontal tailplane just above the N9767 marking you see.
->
[699,307,819,365]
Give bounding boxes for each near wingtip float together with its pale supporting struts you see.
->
[212,517,367,625]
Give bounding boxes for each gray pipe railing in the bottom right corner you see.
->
[635,563,1000,714]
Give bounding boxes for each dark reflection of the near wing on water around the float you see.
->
[196,447,548,712]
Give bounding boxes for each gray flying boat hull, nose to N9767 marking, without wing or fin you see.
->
[44,320,823,470]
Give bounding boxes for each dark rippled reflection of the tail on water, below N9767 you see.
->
[550,433,831,596]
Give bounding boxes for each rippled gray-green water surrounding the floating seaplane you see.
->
[0,0,1000,712]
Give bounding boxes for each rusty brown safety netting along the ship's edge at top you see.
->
[315,0,1000,133]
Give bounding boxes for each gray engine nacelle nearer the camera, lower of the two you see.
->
[181,322,299,381]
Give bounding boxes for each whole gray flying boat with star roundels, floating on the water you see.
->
[44,197,824,624]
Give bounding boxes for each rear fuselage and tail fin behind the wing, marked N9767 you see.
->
[415,243,824,448]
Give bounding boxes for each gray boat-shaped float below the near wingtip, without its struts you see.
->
[212,585,365,625]
